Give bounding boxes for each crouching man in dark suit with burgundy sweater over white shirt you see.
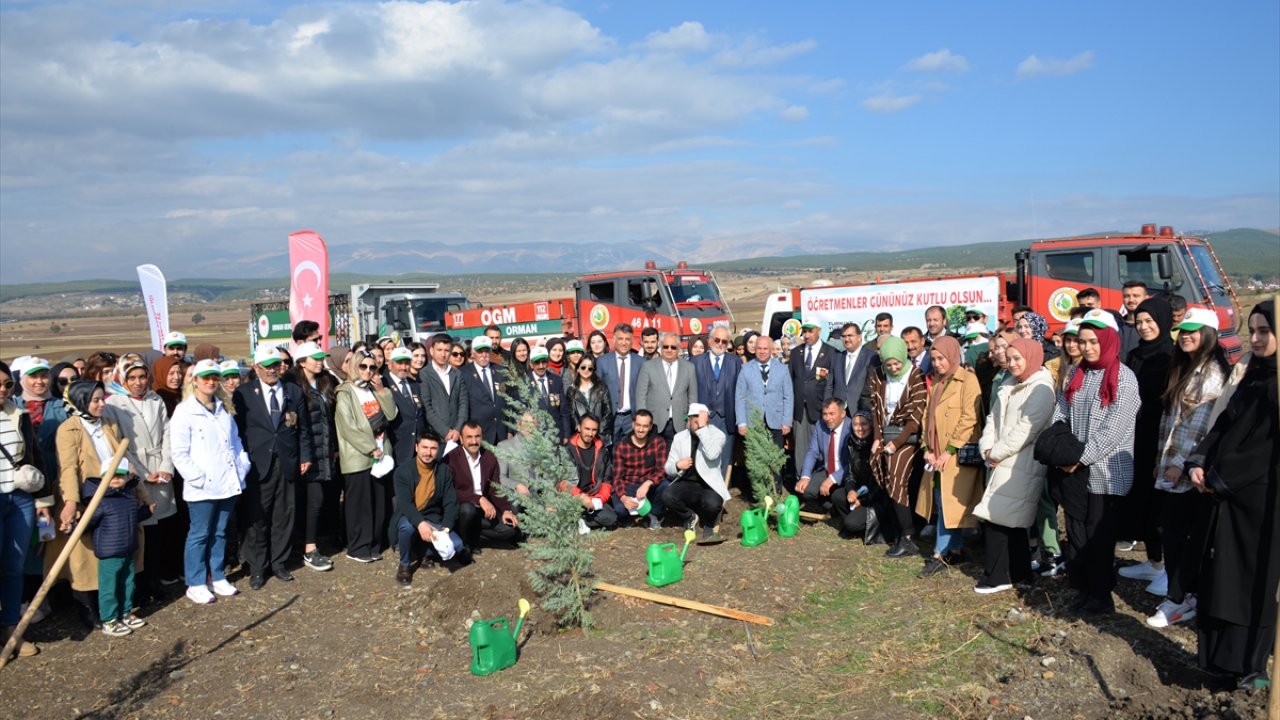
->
[444,420,520,564]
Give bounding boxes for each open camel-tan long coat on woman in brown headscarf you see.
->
[915,368,983,529]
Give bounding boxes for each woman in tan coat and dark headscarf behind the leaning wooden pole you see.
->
[45,380,151,628]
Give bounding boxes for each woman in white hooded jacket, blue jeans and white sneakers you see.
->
[169,360,248,605]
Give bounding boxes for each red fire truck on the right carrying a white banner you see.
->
[762,224,1242,356]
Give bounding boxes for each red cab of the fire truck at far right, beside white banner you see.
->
[1009,224,1242,356]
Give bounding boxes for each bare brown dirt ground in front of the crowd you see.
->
[0,486,1266,720]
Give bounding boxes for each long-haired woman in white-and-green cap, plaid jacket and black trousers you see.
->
[1134,307,1228,628]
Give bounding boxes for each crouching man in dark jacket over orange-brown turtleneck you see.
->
[394,432,463,585]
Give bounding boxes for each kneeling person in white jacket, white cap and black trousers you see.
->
[662,402,728,544]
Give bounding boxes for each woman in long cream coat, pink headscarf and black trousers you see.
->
[973,338,1057,593]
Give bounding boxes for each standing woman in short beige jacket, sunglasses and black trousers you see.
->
[334,350,397,562]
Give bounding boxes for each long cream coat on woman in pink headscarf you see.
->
[973,368,1057,528]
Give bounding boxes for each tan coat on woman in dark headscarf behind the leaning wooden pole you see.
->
[45,416,151,591]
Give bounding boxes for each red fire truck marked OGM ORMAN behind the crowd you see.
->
[445,261,732,342]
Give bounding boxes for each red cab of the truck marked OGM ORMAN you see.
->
[573,261,732,341]
